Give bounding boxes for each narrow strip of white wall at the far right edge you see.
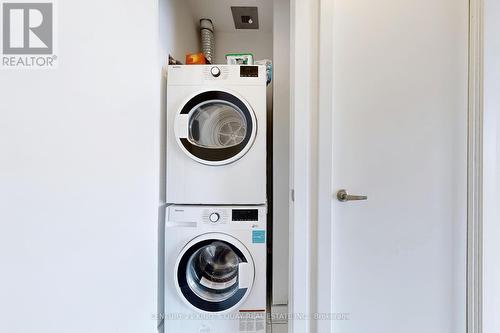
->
[483,0,500,333]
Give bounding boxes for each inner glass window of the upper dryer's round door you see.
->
[189,101,247,149]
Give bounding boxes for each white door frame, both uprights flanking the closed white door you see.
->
[288,0,483,333]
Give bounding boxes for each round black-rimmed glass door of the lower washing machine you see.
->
[176,233,253,312]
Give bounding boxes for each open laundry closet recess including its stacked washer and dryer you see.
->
[158,0,291,333]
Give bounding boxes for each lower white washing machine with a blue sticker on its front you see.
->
[163,205,266,333]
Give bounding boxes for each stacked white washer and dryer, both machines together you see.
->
[164,65,267,333]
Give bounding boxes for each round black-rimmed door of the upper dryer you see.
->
[177,91,257,165]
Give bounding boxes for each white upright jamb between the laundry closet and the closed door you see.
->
[288,0,320,333]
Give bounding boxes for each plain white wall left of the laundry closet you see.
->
[0,0,160,333]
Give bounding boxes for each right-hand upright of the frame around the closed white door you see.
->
[467,0,484,333]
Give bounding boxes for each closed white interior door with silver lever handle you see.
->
[326,0,468,333]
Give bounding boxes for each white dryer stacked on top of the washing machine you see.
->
[166,65,267,205]
